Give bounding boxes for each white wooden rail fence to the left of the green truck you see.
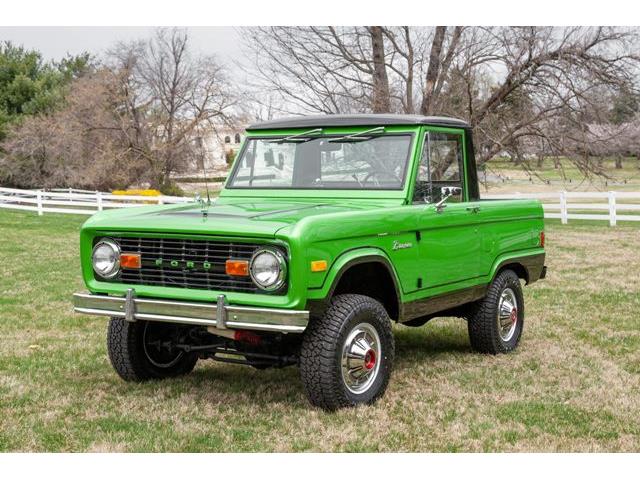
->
[0,187,193,215]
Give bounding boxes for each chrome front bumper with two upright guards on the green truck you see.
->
[73,289,309,333]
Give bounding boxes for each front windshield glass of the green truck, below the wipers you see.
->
[227,134,412,190]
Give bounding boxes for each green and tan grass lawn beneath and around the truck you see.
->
[0,211,640,451]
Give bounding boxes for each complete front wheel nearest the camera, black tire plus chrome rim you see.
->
[300,294,395,410]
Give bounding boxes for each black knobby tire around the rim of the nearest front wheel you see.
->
[300,294,395,411]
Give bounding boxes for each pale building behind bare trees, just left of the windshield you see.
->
[193,124,246,172]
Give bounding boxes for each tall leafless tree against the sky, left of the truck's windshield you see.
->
[108,29,234,188]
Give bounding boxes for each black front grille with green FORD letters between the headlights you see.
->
[109,237,261,293]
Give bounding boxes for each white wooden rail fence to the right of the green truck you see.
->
[481,192,640,227]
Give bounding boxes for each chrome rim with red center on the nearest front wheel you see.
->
[341,323,382,394]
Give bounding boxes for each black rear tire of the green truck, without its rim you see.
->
[467,270,524,354]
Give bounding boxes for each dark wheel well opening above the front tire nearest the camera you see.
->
[333,262,399,320]
